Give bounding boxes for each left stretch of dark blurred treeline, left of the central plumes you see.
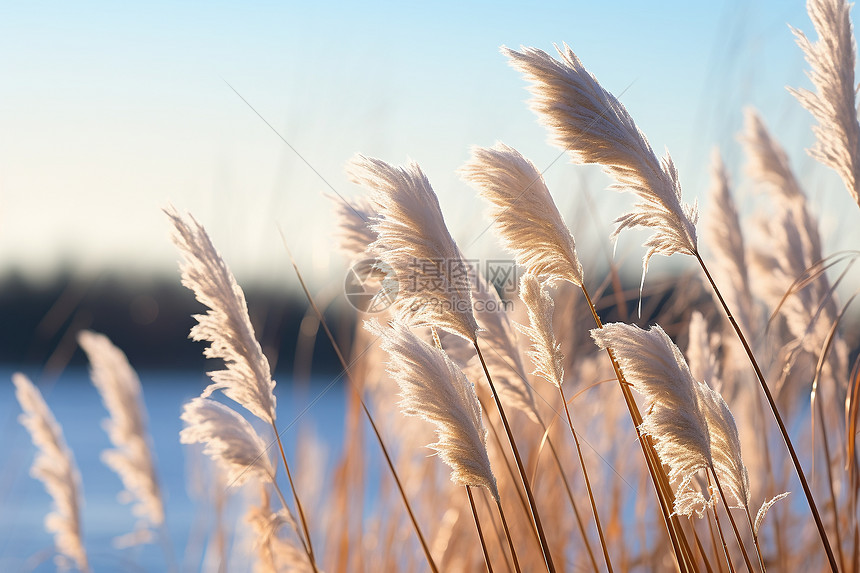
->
[0,274,355,375]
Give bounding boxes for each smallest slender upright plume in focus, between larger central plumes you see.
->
[517,273,564,388]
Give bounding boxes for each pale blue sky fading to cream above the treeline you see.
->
[0,1,857,290]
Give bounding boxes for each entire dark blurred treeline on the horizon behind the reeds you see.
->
[0,273,740,377]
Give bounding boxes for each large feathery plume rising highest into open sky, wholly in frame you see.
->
[502,45,698,278]
